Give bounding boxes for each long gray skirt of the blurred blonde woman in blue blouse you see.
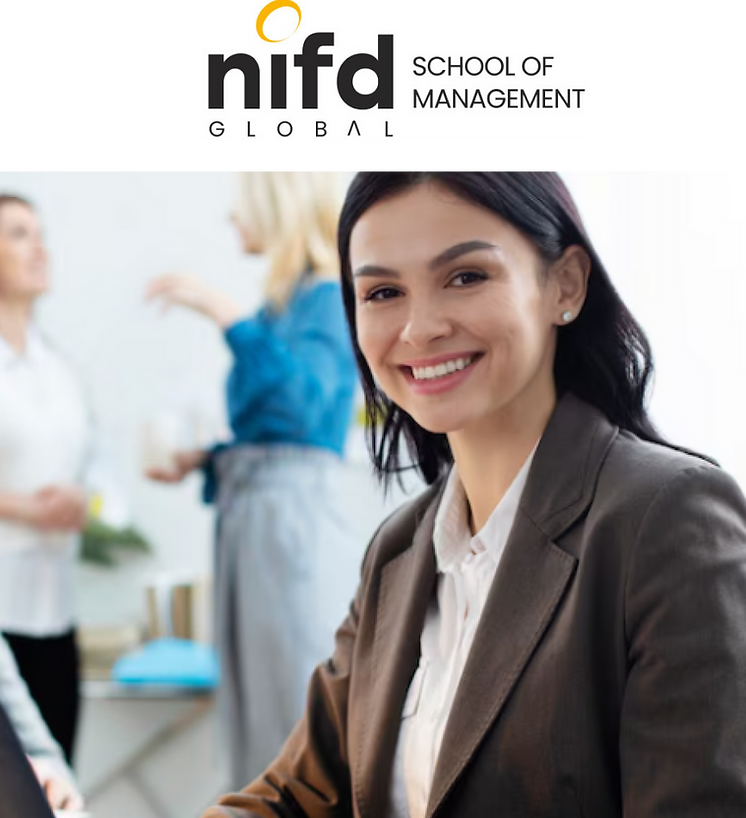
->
[215,446,362,789]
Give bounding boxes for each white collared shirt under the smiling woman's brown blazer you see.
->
[388,443,538,818]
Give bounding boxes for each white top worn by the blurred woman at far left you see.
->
[0,327,92,636]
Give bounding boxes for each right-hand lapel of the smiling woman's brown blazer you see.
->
[427,395,616,818]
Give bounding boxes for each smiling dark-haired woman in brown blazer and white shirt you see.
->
[206,169,746,818]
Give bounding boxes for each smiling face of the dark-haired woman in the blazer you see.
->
[350,183,578,433]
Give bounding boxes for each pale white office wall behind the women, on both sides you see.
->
[0,169,746,623]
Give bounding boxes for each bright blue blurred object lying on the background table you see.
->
[111,637,219,687]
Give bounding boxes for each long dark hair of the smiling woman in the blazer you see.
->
[339,169,704,484]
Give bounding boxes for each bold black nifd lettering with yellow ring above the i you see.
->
[208,0,394,110]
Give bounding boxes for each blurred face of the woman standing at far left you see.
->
[0,202,49,301]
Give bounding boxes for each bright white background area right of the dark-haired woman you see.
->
[562,170,746,488]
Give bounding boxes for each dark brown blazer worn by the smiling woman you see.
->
[203,395,746,818]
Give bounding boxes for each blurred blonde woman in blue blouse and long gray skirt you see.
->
[147,170,359,788]
